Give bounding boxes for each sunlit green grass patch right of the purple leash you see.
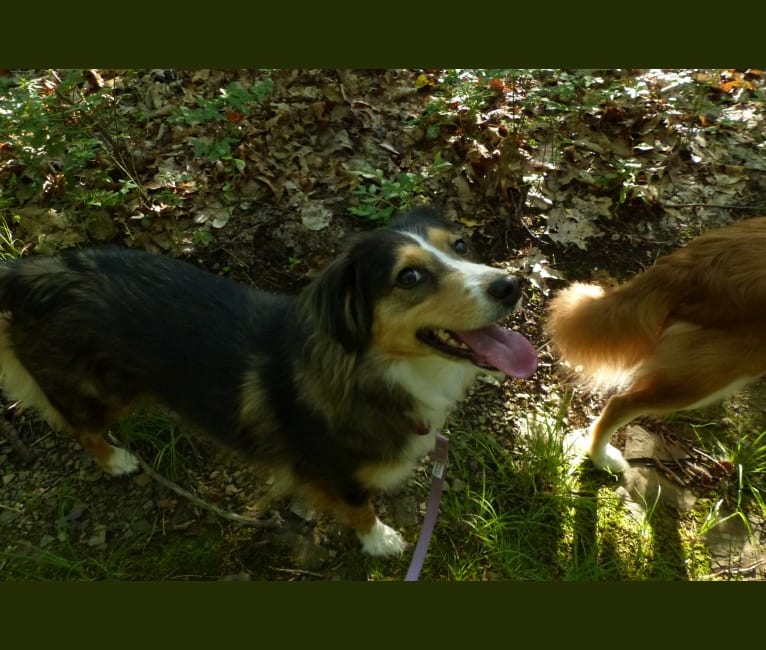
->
[416,388,766,580]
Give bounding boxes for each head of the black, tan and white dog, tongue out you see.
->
[309,208,537,377]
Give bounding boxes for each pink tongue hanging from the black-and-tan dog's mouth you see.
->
[453,325,537,377]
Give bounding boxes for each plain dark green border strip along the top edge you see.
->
[0,0,766,68]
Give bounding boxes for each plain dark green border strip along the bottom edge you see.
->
[0,582,766,648]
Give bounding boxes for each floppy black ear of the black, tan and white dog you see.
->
[309,248,373,353]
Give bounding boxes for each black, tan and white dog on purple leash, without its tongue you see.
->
[0,210,533,554]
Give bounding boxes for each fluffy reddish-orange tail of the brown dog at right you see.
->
[546,276,672,388]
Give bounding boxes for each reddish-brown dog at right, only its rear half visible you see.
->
[547,217,766,472]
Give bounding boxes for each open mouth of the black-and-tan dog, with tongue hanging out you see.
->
[417,325,537,377]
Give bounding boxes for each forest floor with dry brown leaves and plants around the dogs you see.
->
[0,70,766,580]
